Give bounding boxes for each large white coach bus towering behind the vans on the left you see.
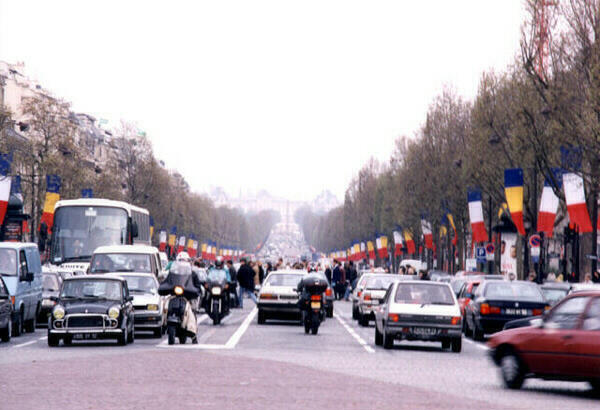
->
[49,198,151,272]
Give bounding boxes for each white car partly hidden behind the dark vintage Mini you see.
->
[111,272,166,337]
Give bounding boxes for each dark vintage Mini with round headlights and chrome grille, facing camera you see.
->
[48,275,134,346]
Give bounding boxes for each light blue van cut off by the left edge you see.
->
[0,242,42,336]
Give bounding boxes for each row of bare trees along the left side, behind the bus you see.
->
[0,94,279,251]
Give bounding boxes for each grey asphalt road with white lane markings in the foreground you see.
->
[0,301,600,410]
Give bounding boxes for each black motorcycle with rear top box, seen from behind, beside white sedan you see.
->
[298,275,327,335]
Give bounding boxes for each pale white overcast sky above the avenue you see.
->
[0,0,526,200]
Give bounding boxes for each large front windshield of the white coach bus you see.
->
[51,206,128,263]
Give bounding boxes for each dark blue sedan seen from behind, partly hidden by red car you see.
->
[465,280,549,340]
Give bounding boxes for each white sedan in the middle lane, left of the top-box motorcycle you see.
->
[257,270,306,324]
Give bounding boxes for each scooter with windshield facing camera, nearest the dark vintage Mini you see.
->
[158,263,200,345]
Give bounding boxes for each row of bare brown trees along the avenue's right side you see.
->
[297,0,600,278]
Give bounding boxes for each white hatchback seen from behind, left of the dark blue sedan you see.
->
[375,280,462,353]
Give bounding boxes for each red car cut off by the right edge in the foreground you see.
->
[488,291,600,390]
